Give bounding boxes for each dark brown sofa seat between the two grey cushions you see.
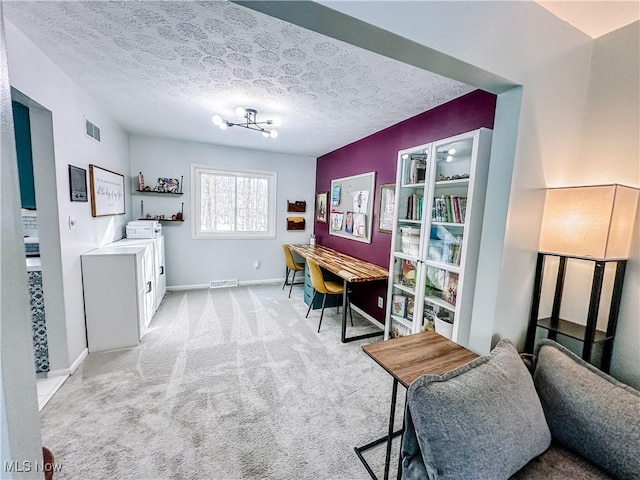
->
[511,442,612,480]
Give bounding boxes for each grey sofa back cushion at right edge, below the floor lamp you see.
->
[534,340,640,478]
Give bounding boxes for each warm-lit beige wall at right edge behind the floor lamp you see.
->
[576,22,640,388]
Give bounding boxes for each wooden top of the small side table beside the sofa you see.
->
[362,331,478,387]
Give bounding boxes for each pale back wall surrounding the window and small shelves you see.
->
[130,132,316,287]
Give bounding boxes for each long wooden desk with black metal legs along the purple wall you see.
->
[289,244,389,343]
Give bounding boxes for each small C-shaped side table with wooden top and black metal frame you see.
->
[354,331,478,480]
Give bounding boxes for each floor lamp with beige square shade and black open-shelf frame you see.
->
[525,184,639,372]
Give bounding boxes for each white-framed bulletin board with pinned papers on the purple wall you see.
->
[329,172,376,243]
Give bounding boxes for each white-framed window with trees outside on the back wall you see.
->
[191,164,276,239]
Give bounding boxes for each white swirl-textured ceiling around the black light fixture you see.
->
[3,1,473,156]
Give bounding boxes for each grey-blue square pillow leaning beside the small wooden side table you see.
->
[402,340,551,479]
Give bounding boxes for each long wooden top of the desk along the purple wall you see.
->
[289,244,389,283]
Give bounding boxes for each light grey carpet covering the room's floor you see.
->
[41,285,404,480]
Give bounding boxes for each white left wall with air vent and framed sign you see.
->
[6,21,130,370]
